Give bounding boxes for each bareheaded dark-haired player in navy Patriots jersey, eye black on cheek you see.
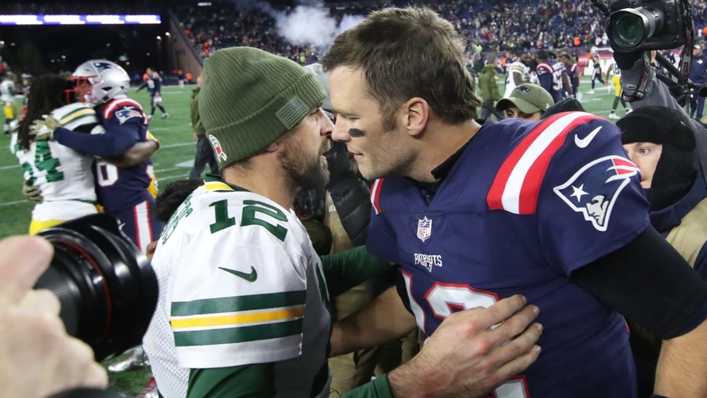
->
[323,8,707,398]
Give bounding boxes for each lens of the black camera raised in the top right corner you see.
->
[608,7,664,51]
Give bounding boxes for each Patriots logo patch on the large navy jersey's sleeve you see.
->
[553,155,638,232]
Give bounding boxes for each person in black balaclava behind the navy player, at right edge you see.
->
[616,106,707,397]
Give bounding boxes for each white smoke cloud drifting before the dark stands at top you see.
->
[234,0,365,47]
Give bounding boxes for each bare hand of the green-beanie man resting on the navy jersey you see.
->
[388,295,542,398]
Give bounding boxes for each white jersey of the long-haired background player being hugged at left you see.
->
[13,103,104,221]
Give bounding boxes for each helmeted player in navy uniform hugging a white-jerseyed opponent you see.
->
[33,60,162,252]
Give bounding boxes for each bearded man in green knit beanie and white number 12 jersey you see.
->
[144,47,539,398]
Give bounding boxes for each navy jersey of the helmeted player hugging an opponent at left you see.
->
[96,98,153,213]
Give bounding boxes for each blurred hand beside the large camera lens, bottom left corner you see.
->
[0,236,108,398]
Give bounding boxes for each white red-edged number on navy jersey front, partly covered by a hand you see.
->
[401,271,530,398]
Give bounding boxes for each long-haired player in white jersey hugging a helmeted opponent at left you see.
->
[15,74,157,234]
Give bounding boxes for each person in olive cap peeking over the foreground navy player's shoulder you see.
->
[496,83,555,122]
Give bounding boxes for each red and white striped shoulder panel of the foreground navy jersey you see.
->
[486,112,611,215]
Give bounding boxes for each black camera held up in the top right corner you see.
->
[607,0,692,53]
